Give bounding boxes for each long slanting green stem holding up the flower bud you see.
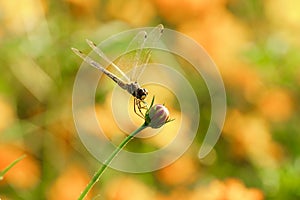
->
[78,123,147,200]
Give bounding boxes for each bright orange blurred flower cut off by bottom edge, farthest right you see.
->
[190,179,264,200]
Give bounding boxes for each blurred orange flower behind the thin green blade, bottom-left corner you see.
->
[0,144,40,189]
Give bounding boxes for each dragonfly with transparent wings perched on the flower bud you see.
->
[71,24,164,119]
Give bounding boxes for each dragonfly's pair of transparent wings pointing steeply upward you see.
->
[117,25,163,82]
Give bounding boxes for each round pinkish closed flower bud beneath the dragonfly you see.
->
[148,104,169,128]
